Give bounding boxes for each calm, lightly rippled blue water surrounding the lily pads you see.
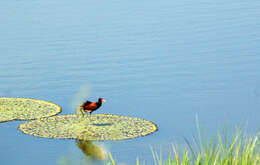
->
[0,0,260,165]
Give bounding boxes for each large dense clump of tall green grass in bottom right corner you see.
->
[149,133,260,165]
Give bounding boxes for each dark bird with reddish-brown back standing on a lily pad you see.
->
[79,97,106,115]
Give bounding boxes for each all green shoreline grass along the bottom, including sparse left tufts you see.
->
[59,122,260,165]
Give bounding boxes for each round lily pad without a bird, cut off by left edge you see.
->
[0,97,61,122]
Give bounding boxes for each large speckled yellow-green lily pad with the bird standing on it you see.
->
[19,114,158,140]
